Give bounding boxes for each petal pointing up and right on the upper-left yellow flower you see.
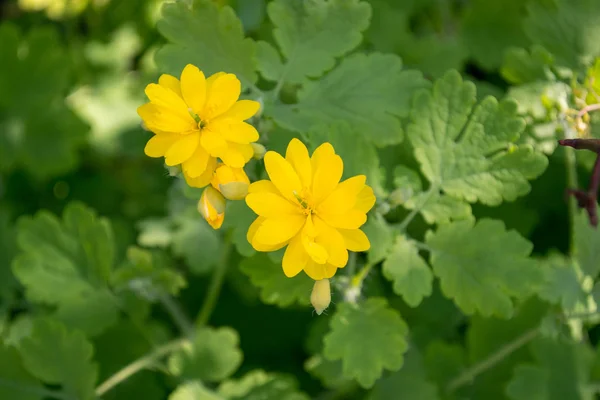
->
[199,74,242,120]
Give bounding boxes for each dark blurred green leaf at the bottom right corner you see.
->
[506,338,594,400]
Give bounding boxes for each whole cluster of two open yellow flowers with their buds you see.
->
[138,65,375,314]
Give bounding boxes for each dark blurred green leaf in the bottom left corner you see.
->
[0,342,45,400]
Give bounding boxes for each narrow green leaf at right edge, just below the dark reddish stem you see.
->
[573,206,600,278]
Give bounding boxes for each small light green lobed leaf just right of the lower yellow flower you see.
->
[382,236,433,307]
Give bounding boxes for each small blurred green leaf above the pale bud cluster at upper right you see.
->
[500,45,554,84]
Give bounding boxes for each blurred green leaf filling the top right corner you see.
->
[524,0,600,69]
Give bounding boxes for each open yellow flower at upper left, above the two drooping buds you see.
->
[138,64,260,187]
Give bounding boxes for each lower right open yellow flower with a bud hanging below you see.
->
[246,139,375,280]
